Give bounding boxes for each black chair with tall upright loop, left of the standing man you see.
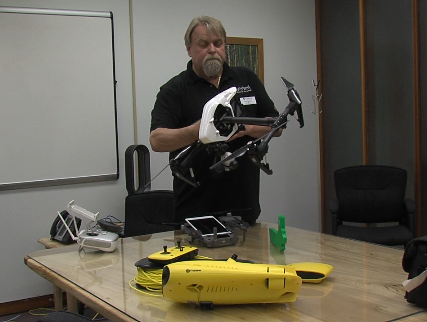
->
[124,145,179,237]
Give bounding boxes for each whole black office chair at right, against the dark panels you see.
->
[330,165,415,246]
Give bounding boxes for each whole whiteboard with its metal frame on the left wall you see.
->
[0,7,119,190]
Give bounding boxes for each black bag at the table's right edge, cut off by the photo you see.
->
[402,236,427,308]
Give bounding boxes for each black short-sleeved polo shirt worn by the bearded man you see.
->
[150,61,278,222]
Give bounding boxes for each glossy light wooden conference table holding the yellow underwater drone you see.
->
[26,223,424,322]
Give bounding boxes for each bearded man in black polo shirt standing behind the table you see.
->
[150,16,279,225]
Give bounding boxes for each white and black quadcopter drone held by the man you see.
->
[170,77,304,187]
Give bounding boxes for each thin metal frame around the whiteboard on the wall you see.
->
[0,7,119,191]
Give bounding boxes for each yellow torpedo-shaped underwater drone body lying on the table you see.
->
[162,258,302,307]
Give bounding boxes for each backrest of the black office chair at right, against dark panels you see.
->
[334,165,407,223]
